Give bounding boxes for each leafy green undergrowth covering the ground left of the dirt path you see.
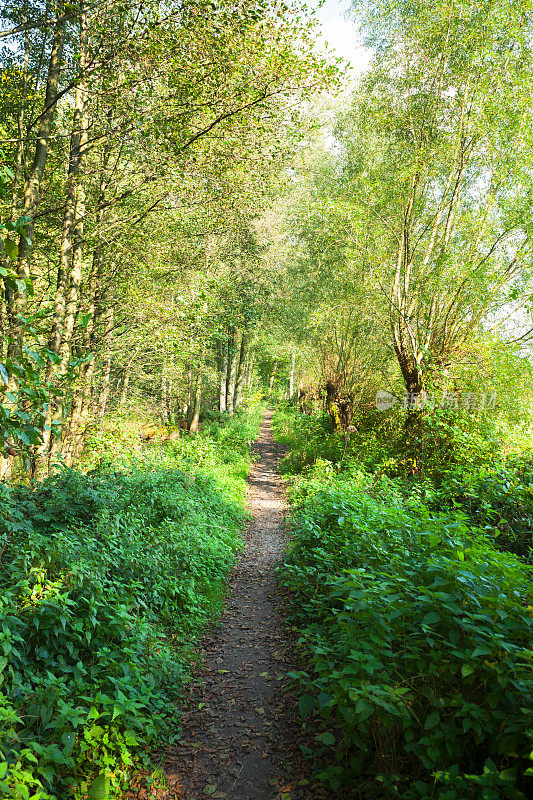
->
[0,410,260,800]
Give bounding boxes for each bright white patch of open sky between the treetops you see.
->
[309,0,371,78]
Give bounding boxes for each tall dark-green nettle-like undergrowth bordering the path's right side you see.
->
[276,413,533,800]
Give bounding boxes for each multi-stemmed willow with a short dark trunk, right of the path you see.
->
[340,2,531,404]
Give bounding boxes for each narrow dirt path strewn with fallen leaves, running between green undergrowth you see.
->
[162,412,324,800]
